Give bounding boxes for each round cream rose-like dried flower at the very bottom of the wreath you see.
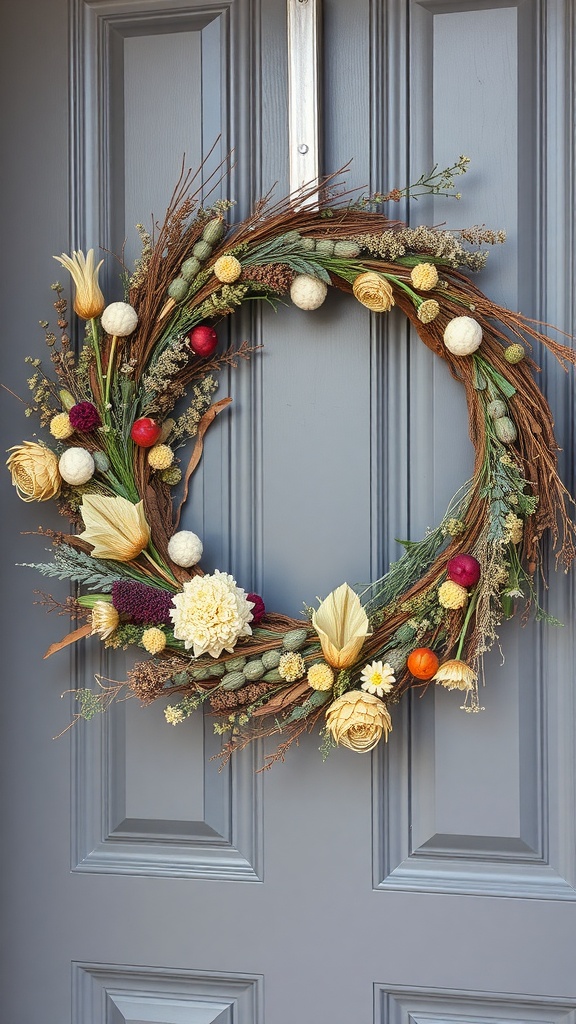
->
[326,690,392,754]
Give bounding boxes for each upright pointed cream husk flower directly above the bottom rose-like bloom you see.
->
[312,583,370,669]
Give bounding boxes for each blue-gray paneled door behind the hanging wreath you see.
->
[0,0,576,1024]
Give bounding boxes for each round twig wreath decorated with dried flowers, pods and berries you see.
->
[7,158,575,766]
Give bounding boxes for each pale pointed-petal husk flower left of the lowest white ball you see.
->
[80,495,150,562]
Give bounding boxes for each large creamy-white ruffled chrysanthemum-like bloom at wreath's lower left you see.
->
[170,569,254,657]
